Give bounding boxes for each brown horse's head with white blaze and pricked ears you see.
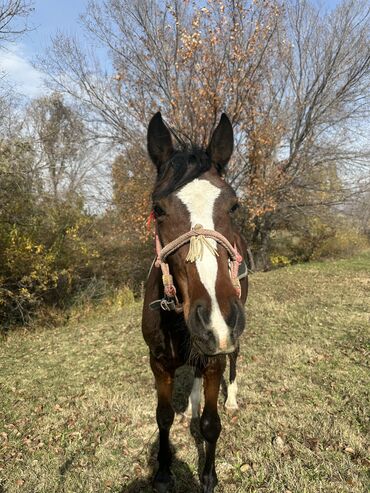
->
[148,113,246,355]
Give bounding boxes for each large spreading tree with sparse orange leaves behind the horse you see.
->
[36,0,370,265]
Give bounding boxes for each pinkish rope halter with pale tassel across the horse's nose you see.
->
[149,215,243,310]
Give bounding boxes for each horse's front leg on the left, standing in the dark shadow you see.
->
[150,355,175,493]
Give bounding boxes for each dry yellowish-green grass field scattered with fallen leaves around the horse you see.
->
[0,253,370,493]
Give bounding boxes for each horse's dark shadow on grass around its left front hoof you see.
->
[120,438,200,493]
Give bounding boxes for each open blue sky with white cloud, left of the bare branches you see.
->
[0,0,339,98]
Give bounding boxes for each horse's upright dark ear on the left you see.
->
[147,111,174,171]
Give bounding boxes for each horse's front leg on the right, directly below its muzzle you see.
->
[200,356,226,493]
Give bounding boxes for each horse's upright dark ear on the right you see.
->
[207,113,234,174]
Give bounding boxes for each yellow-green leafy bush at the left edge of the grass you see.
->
[0,195,98,328]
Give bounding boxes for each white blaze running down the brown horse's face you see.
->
[177,178,229,349]
